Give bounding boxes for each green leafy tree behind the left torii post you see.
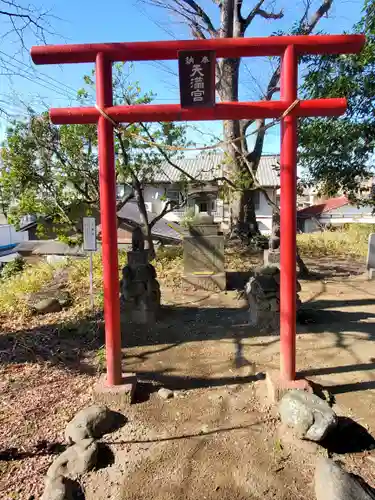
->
[0,64,191,257]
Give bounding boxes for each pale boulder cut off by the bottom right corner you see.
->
[315,457,375,500]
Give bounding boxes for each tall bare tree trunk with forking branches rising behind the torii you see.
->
[143,0,333,242]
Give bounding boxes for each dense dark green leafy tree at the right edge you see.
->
[299,0,375,203]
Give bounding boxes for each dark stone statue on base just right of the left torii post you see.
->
[120,227,160,324]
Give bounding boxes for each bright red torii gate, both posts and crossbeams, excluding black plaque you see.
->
[31,35,365,386]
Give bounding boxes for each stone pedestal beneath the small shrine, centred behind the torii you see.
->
[183,214,226,291]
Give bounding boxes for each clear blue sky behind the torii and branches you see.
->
[0,0,363,153]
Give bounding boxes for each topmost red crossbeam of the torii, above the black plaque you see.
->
[31,35,365,64]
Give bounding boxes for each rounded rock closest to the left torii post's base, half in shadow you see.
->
[65,405,121,444]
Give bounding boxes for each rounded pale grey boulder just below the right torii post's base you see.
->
[279,390,337,441]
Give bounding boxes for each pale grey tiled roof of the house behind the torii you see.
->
[153,154,280,187]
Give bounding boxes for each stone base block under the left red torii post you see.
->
[93,373,137,408]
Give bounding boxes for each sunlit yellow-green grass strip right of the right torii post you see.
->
[297,224,375,258]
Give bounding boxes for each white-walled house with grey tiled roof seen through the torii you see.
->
[117,154,280,233]
